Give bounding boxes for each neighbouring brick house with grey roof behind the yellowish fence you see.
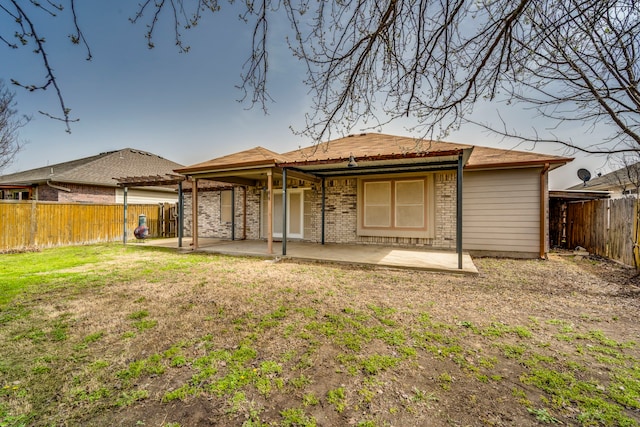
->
[0,148,182,204]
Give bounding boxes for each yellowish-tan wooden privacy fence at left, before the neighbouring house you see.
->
[0,201,174,251]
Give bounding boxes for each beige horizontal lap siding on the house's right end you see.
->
[462,168,540,254]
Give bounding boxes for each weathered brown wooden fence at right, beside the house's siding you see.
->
[567,198,640,267]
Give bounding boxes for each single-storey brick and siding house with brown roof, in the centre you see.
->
[176,133,572,257]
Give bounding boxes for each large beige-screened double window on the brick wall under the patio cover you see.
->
[358,175,434,237]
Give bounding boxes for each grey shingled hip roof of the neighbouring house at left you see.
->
[0,148,182,187]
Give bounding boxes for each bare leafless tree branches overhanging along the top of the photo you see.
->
[0,0,640,157]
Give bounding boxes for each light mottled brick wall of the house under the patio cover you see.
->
[184,172,456,249]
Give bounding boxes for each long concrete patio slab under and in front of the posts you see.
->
[129,237,478,274]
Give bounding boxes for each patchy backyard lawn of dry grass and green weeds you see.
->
[0,244,640,427]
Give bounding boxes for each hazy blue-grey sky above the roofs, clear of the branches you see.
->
[0,0,612,189]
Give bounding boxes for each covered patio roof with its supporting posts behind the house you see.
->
[175,138,473,268]
